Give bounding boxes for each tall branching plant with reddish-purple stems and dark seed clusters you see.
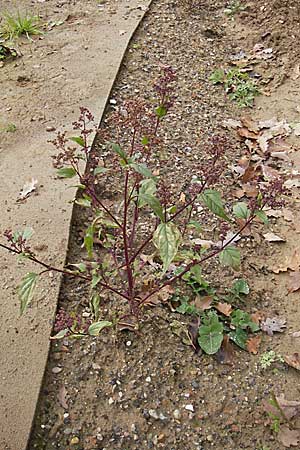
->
[0,67,282,353]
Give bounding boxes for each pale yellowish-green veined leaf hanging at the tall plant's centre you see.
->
[153,222,181,273]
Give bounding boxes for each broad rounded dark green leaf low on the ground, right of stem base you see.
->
[198,312,223,355]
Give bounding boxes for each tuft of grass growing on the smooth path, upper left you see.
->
[0,11,42,41]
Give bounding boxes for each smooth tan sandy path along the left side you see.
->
[0,0,149,450]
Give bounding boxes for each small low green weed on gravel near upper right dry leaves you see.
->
[209,68,259,108]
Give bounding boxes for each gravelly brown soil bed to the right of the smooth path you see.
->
[2,0,300,450]
